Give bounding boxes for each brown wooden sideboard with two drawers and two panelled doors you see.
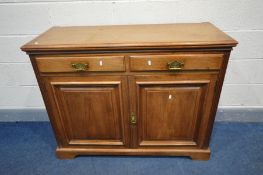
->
[21,23,237,160]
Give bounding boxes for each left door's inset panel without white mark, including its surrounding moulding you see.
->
[53,83,124,145]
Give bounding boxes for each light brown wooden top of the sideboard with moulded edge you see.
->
[21,22,237,52]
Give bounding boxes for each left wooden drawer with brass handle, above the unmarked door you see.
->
[36,56,125,72]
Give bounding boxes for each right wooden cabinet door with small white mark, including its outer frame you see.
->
[130,73,217,147]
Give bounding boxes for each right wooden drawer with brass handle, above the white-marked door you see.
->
[130,54,223,71]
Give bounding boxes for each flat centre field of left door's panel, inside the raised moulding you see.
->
[61,88,120,139]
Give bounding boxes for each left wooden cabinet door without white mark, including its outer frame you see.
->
[43,76,128,147]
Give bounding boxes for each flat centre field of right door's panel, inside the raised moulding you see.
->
[141,86,200,140]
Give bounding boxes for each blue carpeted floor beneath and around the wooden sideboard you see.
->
[0,122,263,175]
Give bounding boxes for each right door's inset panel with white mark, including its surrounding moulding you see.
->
[137,80,209,146]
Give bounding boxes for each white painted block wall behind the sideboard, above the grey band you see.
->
[0,0,263,109]
